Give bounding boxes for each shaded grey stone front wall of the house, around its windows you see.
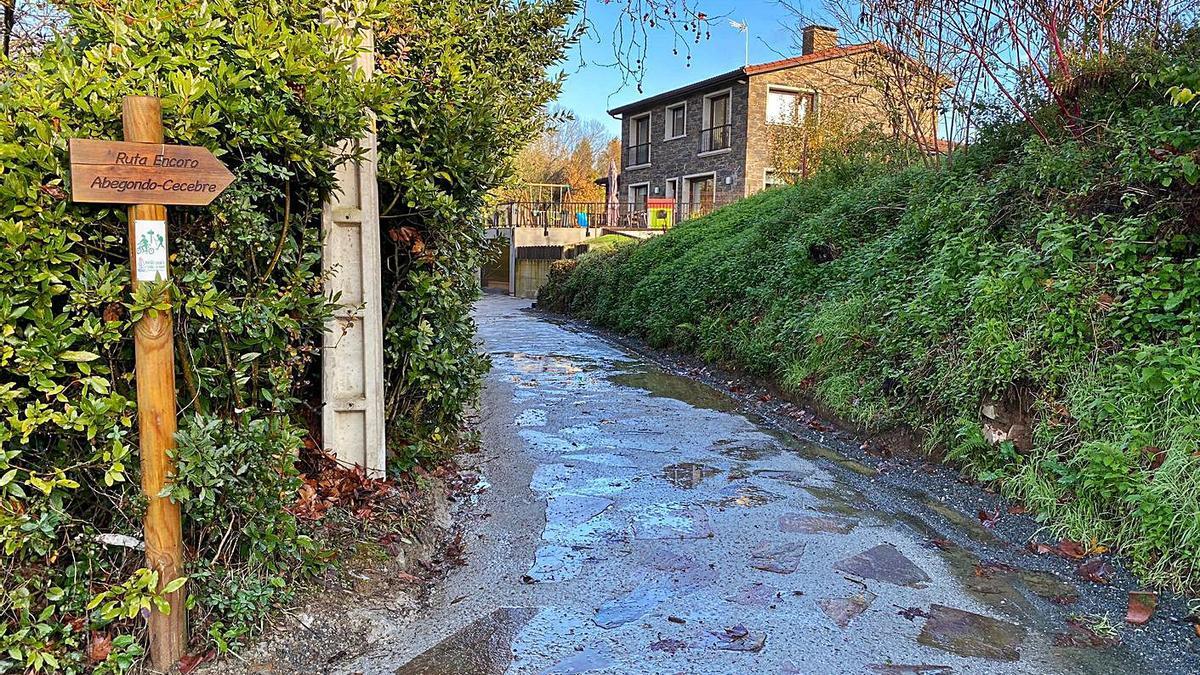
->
[618,78,749,211]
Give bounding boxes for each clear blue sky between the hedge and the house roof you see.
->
[557,0,828,136]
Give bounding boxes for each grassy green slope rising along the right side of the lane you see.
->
[541,63,1200,587]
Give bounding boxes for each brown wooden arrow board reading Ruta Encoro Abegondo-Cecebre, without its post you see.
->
[70,138,233,207]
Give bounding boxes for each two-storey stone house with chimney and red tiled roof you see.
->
[608,25,940,217]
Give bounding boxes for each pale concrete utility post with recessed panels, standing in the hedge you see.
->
[322,28,386,477]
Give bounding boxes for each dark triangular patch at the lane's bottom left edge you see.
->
[396,608,538,675]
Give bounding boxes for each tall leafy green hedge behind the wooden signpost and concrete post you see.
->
[0,0,574,673]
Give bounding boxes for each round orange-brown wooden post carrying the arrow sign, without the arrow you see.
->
[122,96,187,673]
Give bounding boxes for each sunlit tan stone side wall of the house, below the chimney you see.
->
[745,53,937,195]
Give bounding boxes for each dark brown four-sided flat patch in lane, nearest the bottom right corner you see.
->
[917,604,1025,661]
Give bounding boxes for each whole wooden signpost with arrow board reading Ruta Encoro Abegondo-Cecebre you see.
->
[70,96,233,671]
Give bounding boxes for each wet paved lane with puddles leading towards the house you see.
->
[338,295,1151,675]
